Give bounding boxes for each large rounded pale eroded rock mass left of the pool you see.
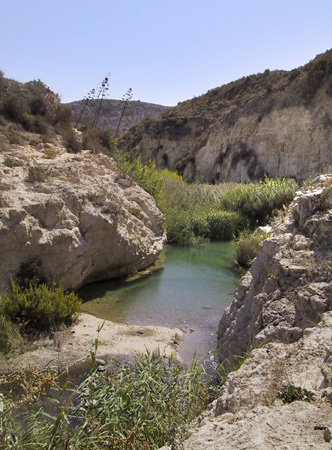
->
[0,144,165,292]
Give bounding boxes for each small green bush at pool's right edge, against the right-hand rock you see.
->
[234,230,268,268]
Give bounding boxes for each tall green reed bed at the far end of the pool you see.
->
[113,152,297,245]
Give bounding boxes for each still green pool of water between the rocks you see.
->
[79,242,239,362]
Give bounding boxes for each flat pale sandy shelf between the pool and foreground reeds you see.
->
[0,313,185,373]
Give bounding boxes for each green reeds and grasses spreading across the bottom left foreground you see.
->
[0,352,209,450]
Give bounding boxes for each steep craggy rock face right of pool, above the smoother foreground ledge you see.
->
[218,176,332,368]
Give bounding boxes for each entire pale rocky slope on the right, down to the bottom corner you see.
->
[163,176,332,450]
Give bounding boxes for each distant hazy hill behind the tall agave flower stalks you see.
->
[67,99,168,134]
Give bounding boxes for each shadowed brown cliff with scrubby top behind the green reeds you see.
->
[121,50,332,183]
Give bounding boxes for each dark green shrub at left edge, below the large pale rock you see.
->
[0,280,81,330]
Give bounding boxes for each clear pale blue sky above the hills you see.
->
[0,0,332,106]
